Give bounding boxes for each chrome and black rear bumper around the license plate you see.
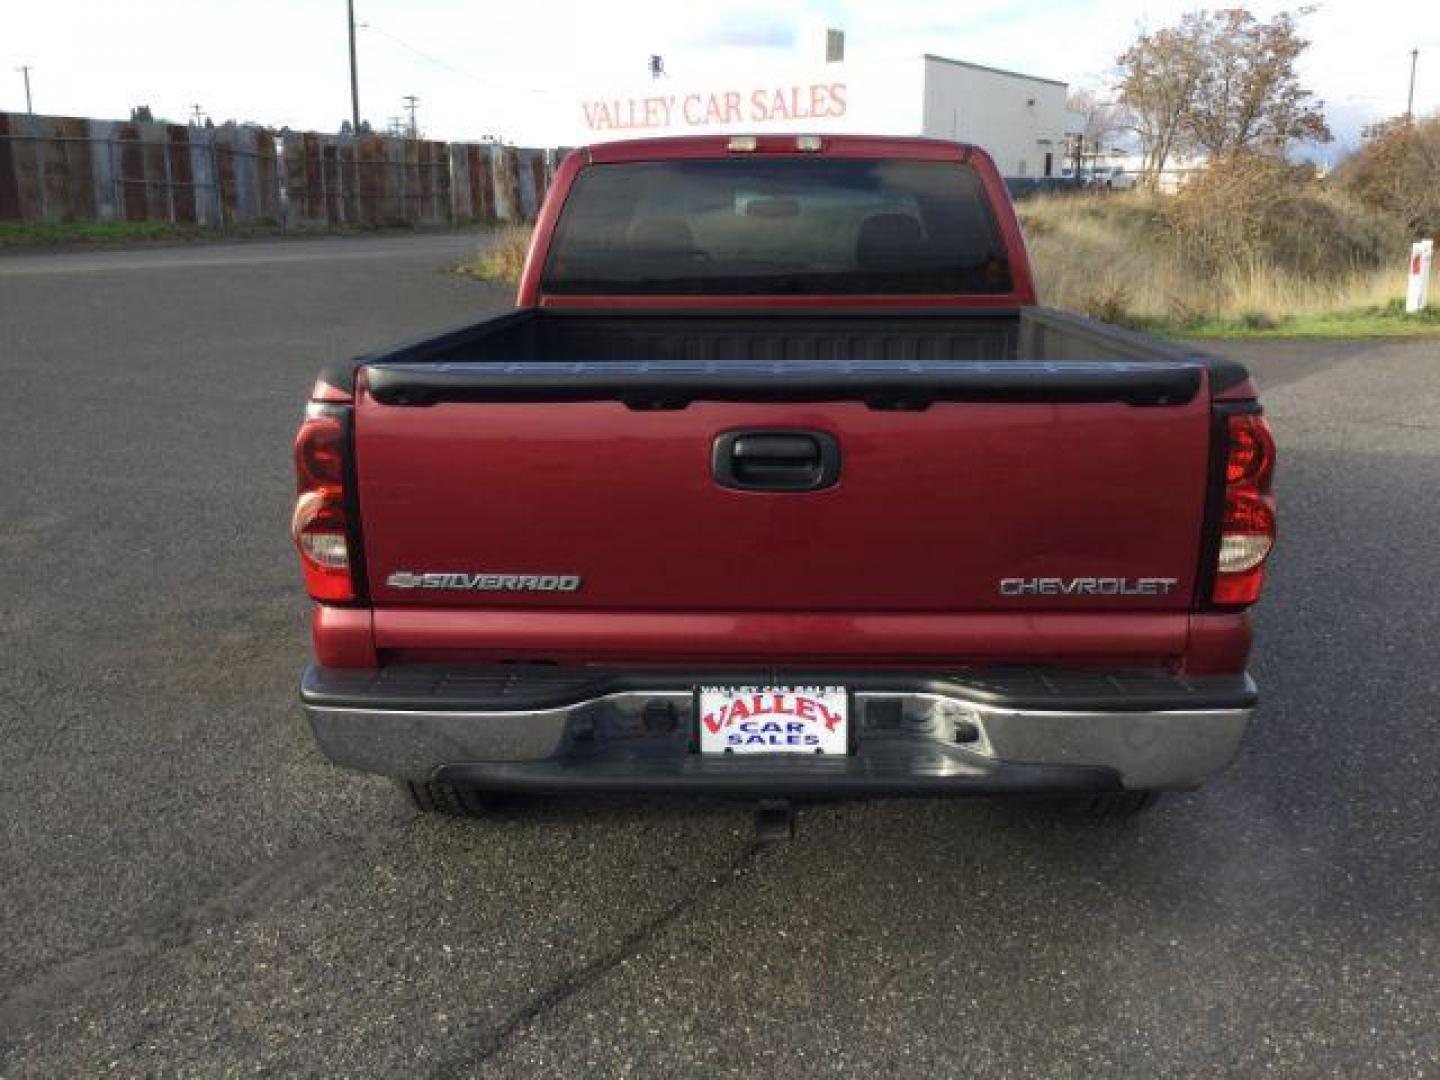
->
[301,668,1254,795]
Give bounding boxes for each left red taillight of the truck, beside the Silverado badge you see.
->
[289,402,356,600]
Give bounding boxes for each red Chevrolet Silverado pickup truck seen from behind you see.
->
[294,135,1274,814]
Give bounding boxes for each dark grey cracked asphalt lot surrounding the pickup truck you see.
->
[0,236,1440,1080]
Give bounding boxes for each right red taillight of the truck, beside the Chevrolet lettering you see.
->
[1211,413,1274,605]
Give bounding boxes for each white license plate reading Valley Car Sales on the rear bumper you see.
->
[696,687,850,755]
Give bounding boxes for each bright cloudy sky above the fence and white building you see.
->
[0,0,1440,158]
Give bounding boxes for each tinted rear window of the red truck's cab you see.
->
[541,157,1011,295]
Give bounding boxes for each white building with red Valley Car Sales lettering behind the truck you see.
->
[546,45,1076,177]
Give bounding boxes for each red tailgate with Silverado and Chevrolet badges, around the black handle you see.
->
[356,364,1210,613]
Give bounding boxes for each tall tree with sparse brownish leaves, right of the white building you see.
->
[1117,7,1331,185]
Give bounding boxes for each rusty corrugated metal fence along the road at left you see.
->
[0,112,562,228]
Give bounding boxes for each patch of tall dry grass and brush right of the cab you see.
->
[1020,168,1408,331]
